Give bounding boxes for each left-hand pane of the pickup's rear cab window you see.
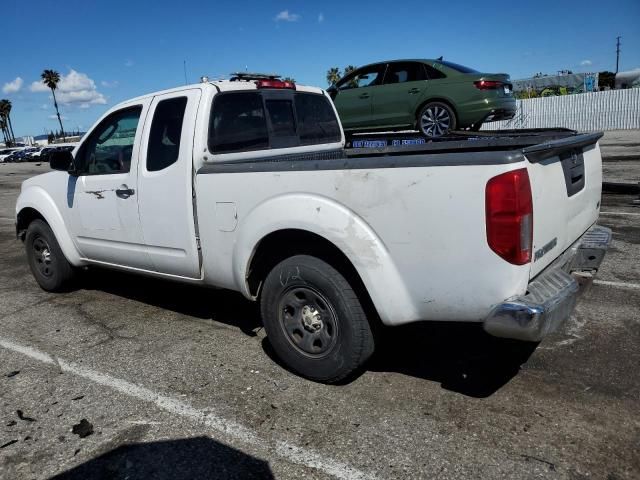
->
[209,92,269,153]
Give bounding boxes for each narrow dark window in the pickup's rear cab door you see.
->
[147,97,187,172]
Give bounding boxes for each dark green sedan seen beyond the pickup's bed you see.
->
[327,59,516,137]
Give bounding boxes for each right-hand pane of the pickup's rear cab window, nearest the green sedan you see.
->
[295,93,340,145]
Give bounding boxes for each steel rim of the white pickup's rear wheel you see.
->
[278,287,338,358]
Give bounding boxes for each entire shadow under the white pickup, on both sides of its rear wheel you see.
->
[80,269,537,398]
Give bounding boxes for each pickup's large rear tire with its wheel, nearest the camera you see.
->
[260,255,374,383]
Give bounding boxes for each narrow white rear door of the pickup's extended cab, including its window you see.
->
[138,89,201,278]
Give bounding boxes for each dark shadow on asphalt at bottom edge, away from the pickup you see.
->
[51,437,274,480]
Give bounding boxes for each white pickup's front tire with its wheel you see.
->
[24,220,74,292]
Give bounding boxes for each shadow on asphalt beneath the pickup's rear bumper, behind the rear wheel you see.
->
[368,322,538,398]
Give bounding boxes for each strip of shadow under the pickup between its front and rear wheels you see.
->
[77,269,262,337]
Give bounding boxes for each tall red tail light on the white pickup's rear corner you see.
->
[485,168,533,265]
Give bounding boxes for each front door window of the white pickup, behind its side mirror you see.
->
[75,107,142,175]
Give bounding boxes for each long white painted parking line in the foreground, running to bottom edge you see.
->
[0,338,375,480]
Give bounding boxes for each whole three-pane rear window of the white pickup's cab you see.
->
[208,89,342,154]
